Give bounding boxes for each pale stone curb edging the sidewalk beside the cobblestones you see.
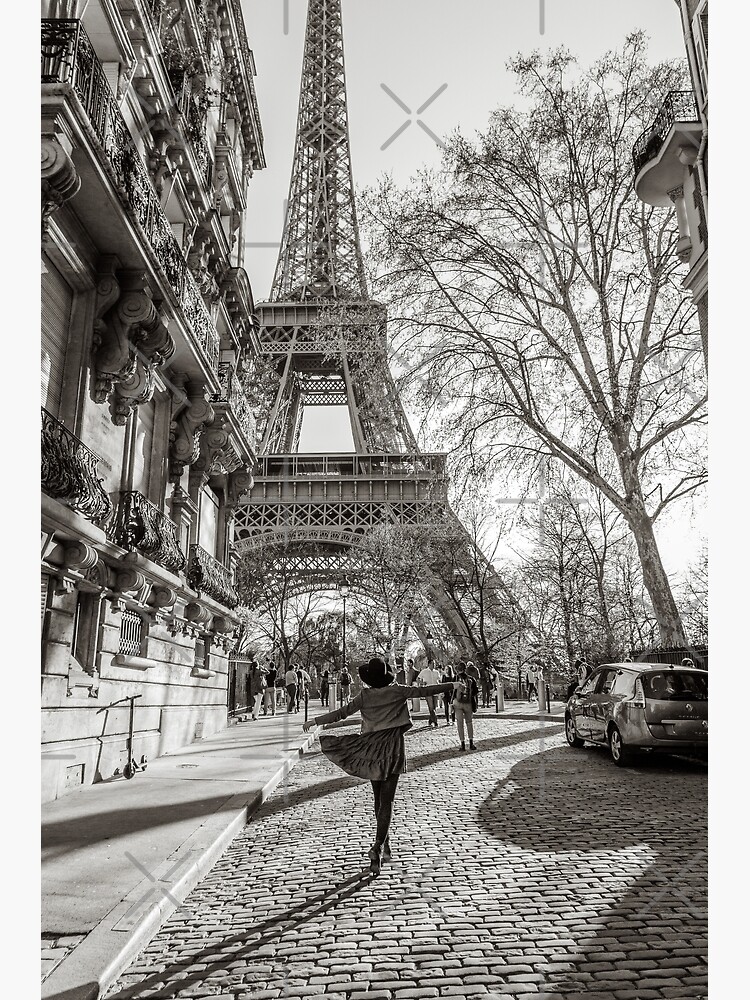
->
[41,731,315,1000]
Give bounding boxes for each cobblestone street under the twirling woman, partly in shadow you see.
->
[107,718,707,1000]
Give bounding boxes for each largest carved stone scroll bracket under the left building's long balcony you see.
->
[94,261,175,425]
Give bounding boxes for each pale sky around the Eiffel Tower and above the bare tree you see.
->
[236,0,703,571]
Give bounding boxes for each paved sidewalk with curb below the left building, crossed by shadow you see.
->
[41,711,314,1000]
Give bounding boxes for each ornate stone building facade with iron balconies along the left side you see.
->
[41,0,265,800]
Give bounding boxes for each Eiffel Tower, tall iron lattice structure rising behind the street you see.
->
[235,0,496,649]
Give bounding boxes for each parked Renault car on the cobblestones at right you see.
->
[565,663,708,766]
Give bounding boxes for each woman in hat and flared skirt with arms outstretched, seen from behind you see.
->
[303,657,454,875]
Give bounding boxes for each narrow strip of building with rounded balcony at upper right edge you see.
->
[633,0,708,364]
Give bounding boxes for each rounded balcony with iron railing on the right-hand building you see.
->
[633,90,702,205]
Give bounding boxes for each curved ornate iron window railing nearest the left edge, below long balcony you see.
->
[42,407,112,525]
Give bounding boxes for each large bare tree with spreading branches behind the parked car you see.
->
[368,35,706,644]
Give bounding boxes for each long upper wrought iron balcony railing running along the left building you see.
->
[42,19,219,371]
